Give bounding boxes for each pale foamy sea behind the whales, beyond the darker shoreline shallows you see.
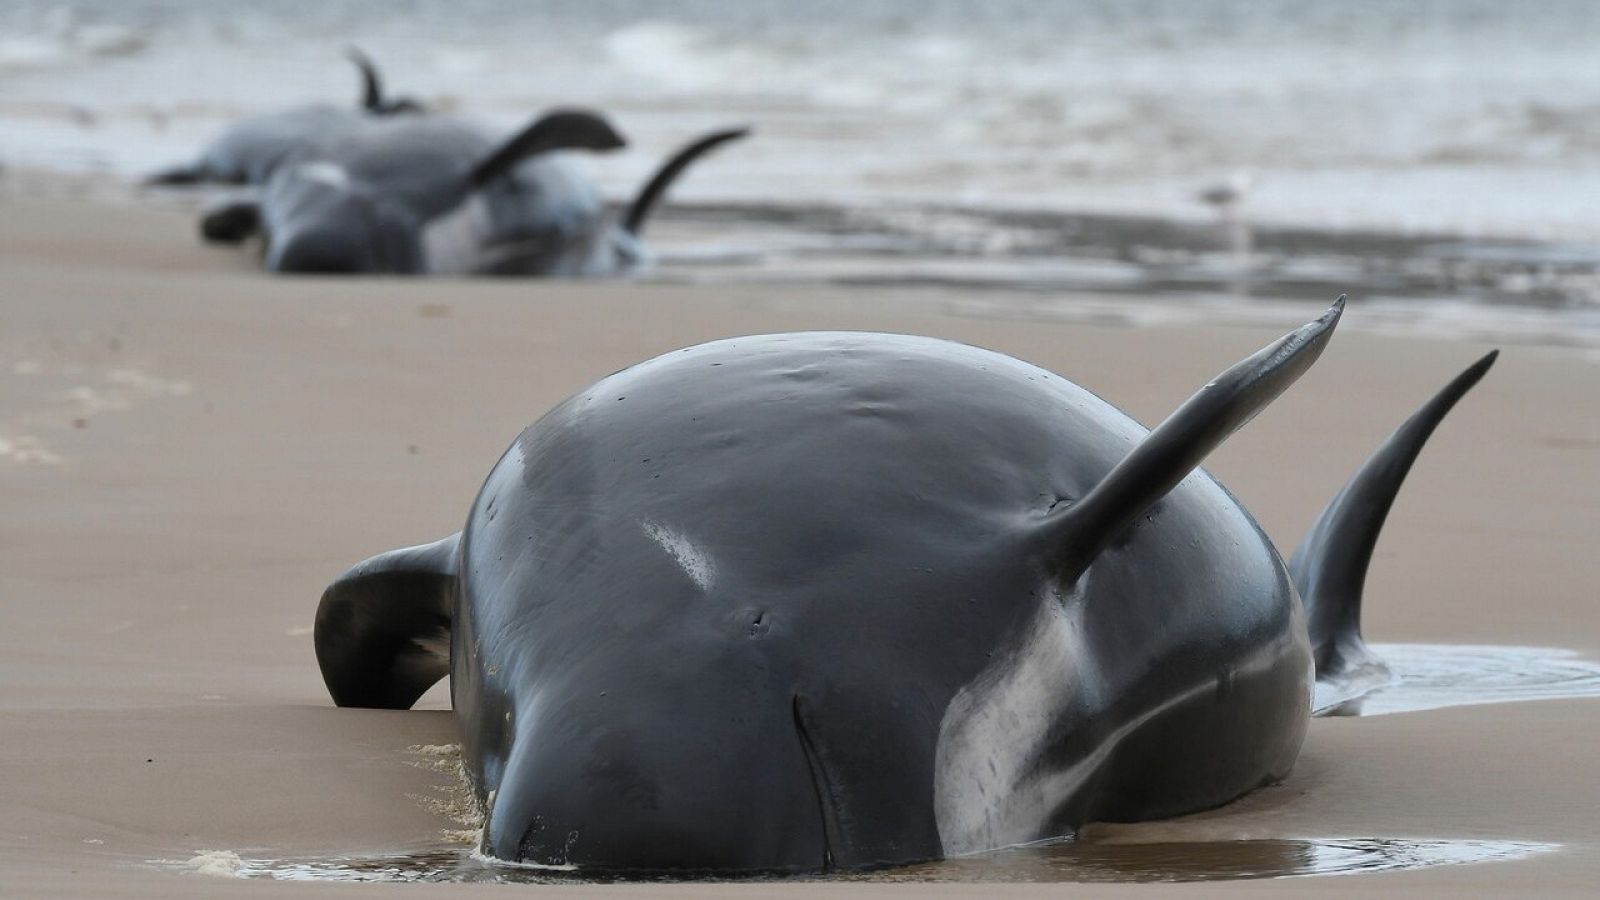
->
[9,0,1600,237]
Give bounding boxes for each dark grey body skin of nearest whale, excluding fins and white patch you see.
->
[453,335,1310,870]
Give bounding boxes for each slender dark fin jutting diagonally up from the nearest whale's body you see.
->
[1045,296,1344,581]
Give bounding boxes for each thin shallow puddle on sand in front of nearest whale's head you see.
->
[172,838,1557,884]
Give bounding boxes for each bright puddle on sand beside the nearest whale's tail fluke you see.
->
[1318,644,1600,716]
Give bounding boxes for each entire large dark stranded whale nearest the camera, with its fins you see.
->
[315,301,1493,873]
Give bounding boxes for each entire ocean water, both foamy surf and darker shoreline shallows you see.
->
[0,0,1600,336]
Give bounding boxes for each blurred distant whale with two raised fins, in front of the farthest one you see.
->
[200,112,747,277]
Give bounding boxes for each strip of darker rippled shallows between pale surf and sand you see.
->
[642,203,1600,348]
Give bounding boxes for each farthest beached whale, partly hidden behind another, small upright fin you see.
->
[146,46,424,186]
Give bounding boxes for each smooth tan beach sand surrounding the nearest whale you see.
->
[0,197,1600,897]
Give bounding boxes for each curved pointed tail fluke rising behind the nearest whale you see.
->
[1290,351,1499,700]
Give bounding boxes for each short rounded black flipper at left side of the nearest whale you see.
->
[315,533,461,709]
